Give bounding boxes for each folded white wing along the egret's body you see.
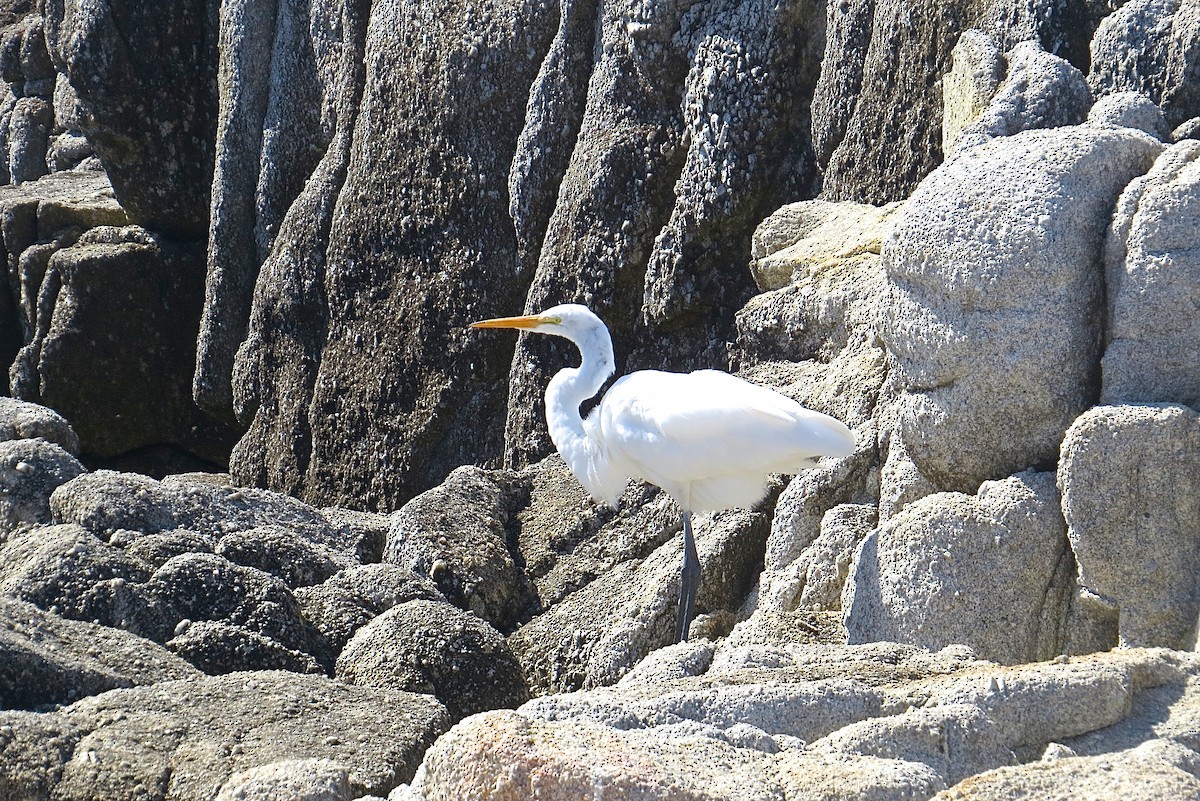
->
[593,371,854,489]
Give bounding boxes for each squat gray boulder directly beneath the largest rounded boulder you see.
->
[841,472,1074,664]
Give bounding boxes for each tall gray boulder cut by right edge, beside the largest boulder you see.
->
[1100,140,1200,405]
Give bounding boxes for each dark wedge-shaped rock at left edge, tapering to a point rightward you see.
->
[0,597,196,709]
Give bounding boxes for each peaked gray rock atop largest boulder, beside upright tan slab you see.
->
[955,42,1092,149]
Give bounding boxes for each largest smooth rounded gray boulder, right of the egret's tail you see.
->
[878,126,1162,499]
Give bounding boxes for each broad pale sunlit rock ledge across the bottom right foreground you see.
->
[394,643,1200,801]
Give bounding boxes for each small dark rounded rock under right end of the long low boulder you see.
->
[216,525,352,589]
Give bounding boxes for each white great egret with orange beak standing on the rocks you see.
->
[470,303,854,642]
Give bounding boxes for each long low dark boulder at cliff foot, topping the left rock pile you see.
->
[50,470,346,550]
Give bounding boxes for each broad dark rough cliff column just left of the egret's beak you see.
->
[225,0,553,508]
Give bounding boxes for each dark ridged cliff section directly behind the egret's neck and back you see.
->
[496,0,820,465]
